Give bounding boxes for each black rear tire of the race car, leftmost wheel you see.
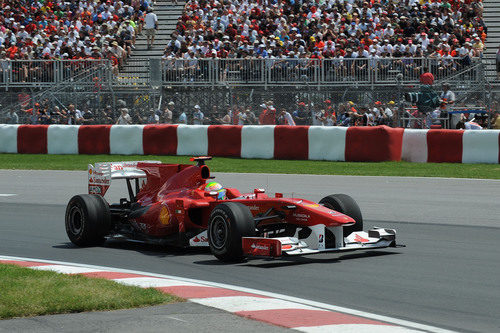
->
[65,194,111,246]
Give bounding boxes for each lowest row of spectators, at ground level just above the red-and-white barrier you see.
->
[2,99,414,126]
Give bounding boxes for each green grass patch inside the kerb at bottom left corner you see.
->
[0,264,182,319]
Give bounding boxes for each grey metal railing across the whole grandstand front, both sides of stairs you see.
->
[0,58,490,88]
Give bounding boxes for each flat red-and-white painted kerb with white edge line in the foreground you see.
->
[0,256,448,333]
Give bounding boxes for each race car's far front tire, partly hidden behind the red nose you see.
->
[319,194,363,237]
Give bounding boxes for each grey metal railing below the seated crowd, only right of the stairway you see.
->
[162,58,482,86]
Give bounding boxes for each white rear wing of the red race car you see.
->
[88,161,161,196]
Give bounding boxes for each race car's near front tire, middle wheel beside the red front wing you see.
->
[207,202,255,262]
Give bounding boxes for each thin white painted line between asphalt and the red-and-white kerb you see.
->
[0,256,455,333]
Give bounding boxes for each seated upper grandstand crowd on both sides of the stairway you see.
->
[0,0,487,85]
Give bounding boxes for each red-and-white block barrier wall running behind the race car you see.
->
[0,125,500,164]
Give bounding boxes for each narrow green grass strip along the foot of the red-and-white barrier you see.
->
[0,154,500,179]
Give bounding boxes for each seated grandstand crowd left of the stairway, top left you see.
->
[0,0,152,67]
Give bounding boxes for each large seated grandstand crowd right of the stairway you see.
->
[164,0,487,77]
